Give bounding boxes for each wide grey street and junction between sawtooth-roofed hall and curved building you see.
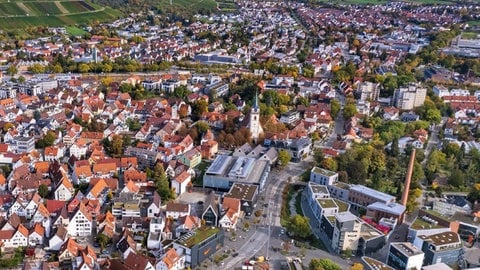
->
[219,157,350,269]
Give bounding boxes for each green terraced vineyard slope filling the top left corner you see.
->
[0,0,121,29]
